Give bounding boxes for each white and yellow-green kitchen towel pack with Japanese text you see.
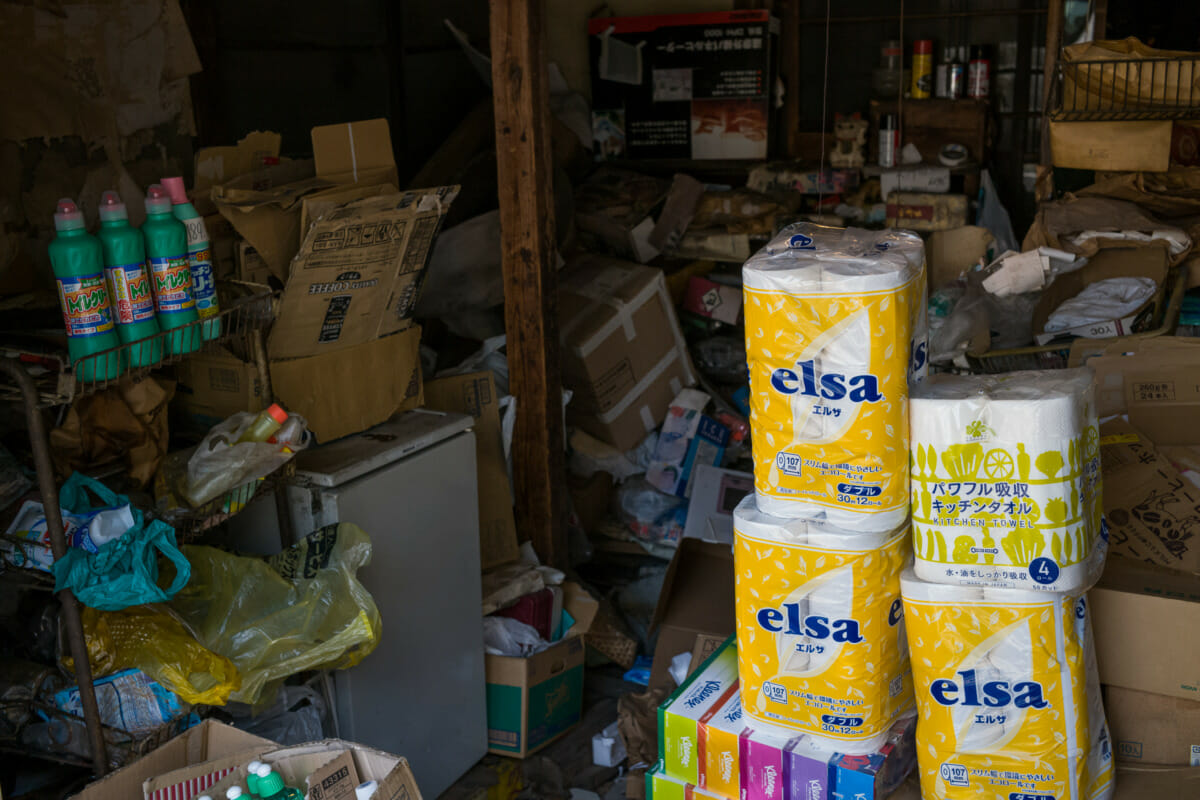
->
[910,368,1108,591]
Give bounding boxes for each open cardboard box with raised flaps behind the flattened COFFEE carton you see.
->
[212,119,398,282]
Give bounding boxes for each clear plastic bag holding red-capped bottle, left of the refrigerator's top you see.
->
[184,411,310,506]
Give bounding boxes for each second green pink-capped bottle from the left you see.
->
[96,191,162,367]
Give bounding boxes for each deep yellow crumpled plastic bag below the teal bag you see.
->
[74,606,241,705]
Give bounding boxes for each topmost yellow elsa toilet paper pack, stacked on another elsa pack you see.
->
[743,223,926,531]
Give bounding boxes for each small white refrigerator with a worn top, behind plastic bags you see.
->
[280,410,487,798]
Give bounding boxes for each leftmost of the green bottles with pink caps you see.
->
[50,197,125,383]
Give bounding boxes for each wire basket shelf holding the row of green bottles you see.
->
[0,282,275,408]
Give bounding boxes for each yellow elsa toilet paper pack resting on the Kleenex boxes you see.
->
[733,494,912,753]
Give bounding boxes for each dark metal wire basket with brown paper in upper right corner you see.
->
[1050,56,1200,122]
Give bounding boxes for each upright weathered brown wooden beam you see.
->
[491,0,566,566]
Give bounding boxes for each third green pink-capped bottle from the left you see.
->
[142,184,204,355]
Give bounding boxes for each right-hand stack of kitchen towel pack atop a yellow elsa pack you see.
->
[900,369,1114,800]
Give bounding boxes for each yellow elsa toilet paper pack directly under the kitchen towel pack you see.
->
[901,570,1114,800]
